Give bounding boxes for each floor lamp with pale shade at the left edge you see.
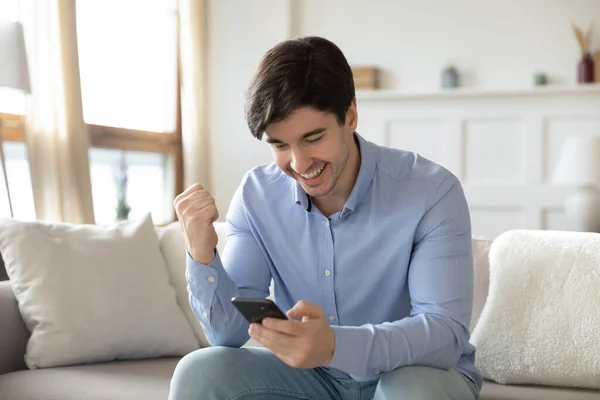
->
[0,20,31,218]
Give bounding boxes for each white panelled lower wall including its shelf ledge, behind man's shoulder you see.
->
[357,85,600,236]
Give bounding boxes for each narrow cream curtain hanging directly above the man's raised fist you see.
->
[179,0,210,188]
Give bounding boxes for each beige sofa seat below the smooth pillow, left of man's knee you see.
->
[0,358,179,400]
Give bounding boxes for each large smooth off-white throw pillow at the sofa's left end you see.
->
[0,215,198,369]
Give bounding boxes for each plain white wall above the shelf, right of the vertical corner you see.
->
[298,0,600,91]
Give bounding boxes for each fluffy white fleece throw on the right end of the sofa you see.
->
[471,230,600,389]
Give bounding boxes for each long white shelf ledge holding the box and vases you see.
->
[356,83,600,102]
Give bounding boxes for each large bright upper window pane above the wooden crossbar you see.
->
[77,0,177,133]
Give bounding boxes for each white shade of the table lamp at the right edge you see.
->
[552,136,600,185]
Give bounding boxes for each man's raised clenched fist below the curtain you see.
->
[173,183,219,264]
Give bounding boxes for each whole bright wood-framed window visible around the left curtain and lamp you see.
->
[0,0,183,224]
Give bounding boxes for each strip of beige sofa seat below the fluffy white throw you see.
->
[481,381,600,400]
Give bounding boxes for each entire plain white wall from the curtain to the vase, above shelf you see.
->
[209,0,600,216]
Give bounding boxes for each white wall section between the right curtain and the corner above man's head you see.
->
[208,0,290,219]
